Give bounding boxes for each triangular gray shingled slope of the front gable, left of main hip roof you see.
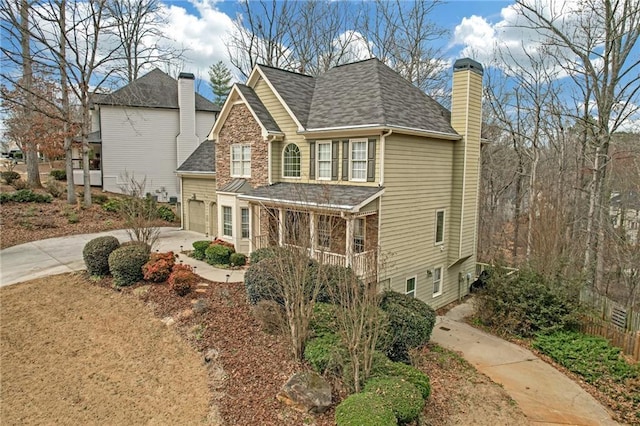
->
[258,65,316,127]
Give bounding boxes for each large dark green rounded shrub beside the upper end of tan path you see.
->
[380,291,436,362]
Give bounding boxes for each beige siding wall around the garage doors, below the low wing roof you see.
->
[182,175,218,237]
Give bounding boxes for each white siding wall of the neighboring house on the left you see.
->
[100,105,215,201]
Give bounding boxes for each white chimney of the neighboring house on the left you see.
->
[176,72,199,167]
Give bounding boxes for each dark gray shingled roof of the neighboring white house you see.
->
[93,68,220,112]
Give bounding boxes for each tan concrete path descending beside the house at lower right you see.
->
[431,303,618,426]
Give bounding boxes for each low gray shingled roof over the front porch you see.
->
[240,182,383,210]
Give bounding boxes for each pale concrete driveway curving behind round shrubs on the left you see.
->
[0,228,244,286]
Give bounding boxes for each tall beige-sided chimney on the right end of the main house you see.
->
[448,58,484,263]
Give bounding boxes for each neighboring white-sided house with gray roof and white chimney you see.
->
[80,69,220,201]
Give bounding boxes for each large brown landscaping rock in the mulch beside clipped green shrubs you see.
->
[277,371,331,413]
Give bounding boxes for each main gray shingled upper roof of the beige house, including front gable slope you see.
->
[260,58,456,134]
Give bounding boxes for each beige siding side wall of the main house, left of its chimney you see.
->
[380,134,473,307]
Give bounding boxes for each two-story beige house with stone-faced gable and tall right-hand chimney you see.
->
[183,59,483,307]
